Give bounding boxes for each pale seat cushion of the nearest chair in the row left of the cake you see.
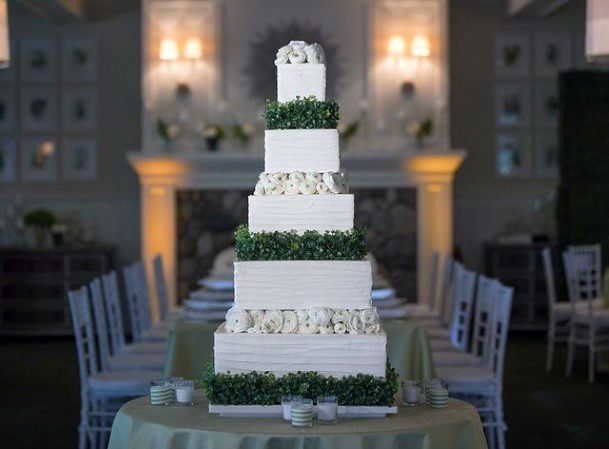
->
[89,370,163,396]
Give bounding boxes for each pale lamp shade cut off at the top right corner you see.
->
[586,0,609,63]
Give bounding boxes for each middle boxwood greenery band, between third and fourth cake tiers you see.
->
[235,225,368,261]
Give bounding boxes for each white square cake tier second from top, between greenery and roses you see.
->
[264,129,340,173]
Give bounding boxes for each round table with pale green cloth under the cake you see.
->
[108,391,486,449]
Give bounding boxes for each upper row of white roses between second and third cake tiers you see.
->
[254,171,349,195]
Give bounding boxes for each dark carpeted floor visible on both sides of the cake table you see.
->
[0,335,609,449]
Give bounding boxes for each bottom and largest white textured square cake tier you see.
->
[214,323,387,379]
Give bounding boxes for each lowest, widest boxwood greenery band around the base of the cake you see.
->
[203,361,399,406]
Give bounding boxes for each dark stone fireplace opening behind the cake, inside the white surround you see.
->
[176,187,417,301]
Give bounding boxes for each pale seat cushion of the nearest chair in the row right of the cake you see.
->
[436,366,495,394]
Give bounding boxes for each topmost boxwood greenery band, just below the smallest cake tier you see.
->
[263,97,340,129]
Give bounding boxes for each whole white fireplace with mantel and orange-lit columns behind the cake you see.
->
[128,150,465,316]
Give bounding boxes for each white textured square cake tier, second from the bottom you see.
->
[235,260,372,310]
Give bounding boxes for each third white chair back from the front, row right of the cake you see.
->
[450,264,476,351]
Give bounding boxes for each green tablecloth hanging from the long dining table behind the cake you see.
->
[164,319,434,380]
